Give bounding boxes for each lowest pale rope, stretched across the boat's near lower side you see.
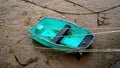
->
[0,43,120,52]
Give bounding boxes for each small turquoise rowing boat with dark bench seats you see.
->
[29,17,95,53]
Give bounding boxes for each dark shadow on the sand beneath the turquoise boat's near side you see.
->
[32,40,92,61]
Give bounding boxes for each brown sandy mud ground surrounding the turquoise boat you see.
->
[0,0,120,68]
